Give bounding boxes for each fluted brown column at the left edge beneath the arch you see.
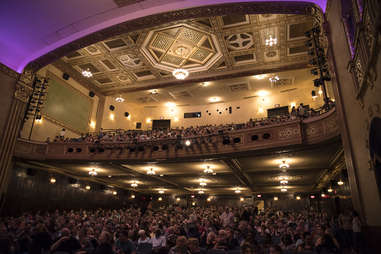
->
[0,66,31,211]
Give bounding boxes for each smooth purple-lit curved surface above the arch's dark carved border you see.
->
[0,0,327,73]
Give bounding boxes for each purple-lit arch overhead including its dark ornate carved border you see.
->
[0,0,327,73]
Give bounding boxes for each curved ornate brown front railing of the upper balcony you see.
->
[15,108,339,161]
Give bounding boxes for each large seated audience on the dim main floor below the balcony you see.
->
[0,206,361,254]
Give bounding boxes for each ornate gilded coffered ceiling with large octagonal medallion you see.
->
[60,14,313,94]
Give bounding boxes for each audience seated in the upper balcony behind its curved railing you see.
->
[46,103,333,144]
